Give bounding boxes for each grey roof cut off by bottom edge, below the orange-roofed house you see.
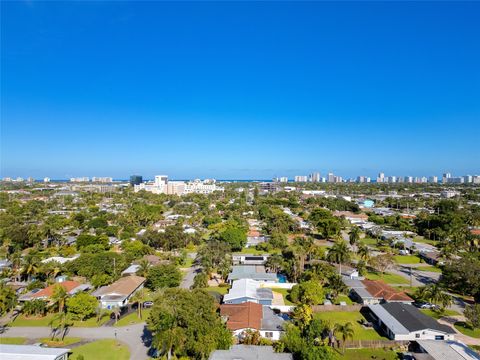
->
[209,345,293,360]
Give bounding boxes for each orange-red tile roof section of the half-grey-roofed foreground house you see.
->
[220,302,263,330]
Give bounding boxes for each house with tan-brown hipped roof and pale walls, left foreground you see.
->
[92,275,146,309]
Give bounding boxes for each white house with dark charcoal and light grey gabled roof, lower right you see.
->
[368,302,455,341]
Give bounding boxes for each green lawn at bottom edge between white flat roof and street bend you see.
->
[69,340,130,360]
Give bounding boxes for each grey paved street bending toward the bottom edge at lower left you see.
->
[1,324,150,360]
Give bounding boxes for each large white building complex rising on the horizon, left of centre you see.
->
[133,175,224,195]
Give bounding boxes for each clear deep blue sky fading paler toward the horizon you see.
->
[0,1,480,179]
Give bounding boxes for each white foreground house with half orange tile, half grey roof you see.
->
[220,301,285,340]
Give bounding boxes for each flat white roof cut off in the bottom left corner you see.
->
[0,345,70,360]
